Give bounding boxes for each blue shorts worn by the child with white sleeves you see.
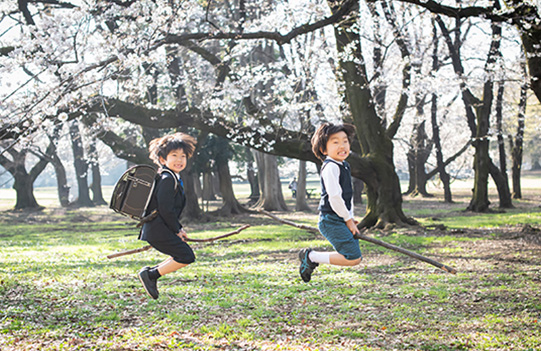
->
[318,213,363,261]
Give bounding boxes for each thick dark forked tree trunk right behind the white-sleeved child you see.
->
[328,1,416,228]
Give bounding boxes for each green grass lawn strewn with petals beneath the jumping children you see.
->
[0,200,541,351]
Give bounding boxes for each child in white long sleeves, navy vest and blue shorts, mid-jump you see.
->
[299,123,362,282]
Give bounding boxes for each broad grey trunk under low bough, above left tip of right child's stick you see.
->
[255,152,288,211]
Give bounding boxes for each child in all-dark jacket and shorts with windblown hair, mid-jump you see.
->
[139,133,196,299]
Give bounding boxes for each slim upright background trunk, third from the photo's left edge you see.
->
[69,120,93,206]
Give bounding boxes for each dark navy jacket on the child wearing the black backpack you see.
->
[139,168,186,242]
